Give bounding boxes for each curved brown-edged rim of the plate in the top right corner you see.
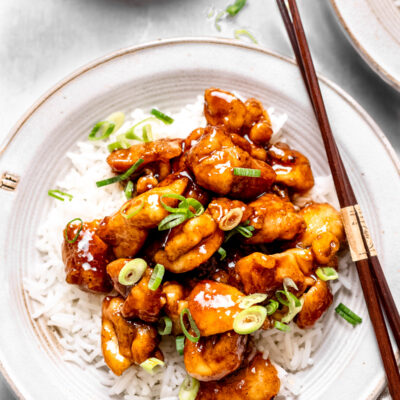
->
[329,0,400,91]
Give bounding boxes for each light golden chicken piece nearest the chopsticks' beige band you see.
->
[296,203,345,247]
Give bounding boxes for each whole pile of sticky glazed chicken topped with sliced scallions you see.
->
[62,88,345,400]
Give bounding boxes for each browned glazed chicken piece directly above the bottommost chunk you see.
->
[183,331,248,382]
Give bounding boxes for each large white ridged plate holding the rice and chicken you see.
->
[0,39,400,400]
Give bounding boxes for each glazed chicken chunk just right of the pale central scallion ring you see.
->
[246,193,306,244]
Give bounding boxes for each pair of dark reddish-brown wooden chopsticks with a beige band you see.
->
[276,0,400,400]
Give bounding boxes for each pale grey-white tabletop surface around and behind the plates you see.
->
[0,0,400,400]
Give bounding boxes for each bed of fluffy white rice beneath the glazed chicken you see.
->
[24,96,348,400]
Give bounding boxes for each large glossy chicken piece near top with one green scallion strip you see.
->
[186,127,275,199]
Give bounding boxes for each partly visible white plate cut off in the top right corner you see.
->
[331,0,400,90]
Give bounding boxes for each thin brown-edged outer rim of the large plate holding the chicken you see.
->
[0,36,400,400]
